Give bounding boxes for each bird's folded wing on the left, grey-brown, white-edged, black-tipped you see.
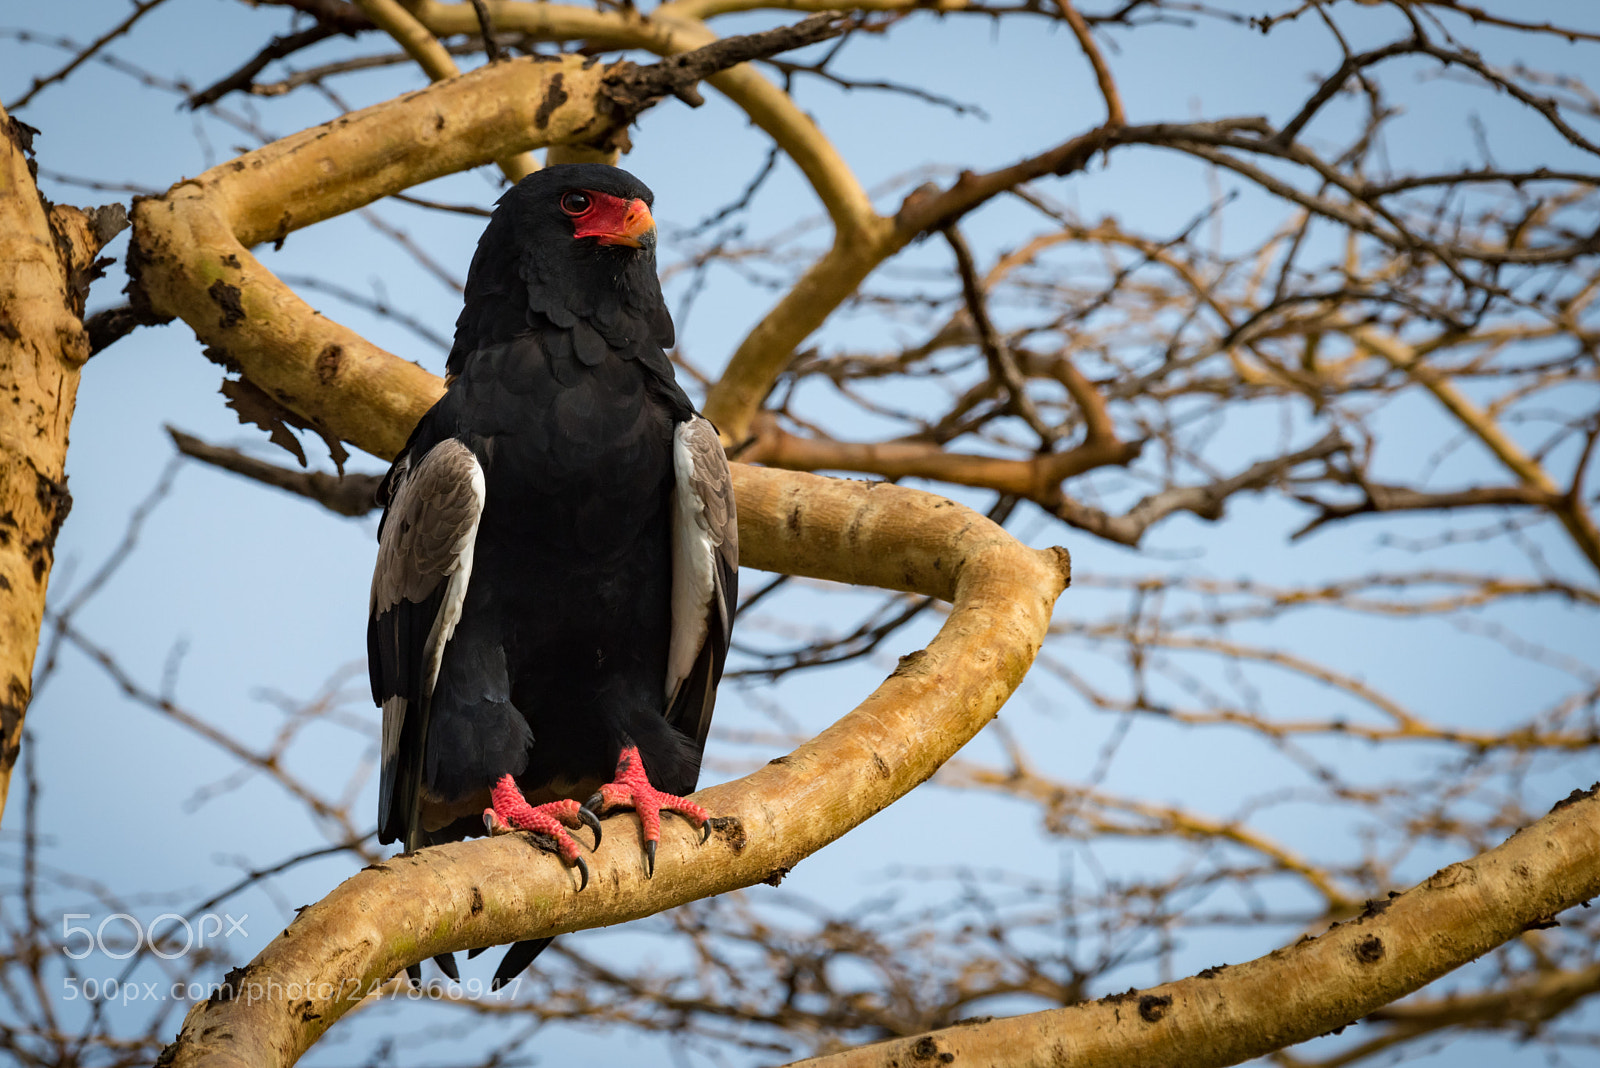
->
[366,438,485,849]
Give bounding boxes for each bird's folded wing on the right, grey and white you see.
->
[667,416,739,747]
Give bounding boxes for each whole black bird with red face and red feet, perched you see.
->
[366,163,739,986]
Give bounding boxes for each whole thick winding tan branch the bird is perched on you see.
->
[124,43,1067,1065]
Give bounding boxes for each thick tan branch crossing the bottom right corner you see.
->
[789,791,1600,1068]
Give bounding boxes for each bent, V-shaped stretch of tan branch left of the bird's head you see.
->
[130,56,611,457]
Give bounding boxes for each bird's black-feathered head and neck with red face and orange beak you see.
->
[451,163,672,366]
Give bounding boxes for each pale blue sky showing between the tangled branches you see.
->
[0,0,1600,1065]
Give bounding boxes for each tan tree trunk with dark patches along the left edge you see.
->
[0,109,115,814]
